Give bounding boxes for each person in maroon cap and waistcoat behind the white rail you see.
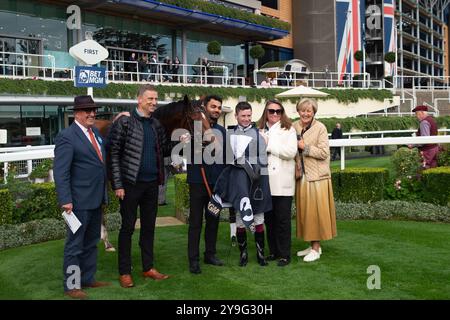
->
[409,106,439,169]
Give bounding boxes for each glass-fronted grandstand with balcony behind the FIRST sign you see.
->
[0,0,293,146]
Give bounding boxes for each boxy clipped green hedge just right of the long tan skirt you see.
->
[331,168,389,203]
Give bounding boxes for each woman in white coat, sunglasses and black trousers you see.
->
[258,100,297,267]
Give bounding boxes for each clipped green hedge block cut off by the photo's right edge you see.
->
[422,167,450,206]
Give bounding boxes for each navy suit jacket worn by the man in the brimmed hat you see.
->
[53,122,107,211]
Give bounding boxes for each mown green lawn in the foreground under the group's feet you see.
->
[0,221,450,300]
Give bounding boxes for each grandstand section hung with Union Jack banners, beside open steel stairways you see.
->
[293,0,450,87]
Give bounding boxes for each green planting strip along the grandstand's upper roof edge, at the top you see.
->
[160,0,291,31]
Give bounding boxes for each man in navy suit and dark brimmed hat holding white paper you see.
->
[54,96,109,299]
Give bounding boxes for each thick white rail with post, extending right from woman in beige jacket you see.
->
[329,135,450,170]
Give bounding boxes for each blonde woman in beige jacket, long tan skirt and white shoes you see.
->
[293,99,336,262]
